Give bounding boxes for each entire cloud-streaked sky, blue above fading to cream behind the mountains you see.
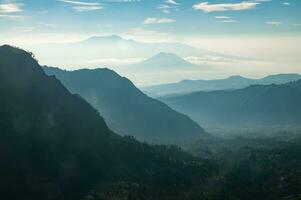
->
[0,0,301,85]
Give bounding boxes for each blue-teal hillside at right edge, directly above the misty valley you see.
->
[162,80,301,131]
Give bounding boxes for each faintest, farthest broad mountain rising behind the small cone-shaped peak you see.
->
[23,35,225,67]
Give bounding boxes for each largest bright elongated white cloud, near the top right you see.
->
[193,1,260,13]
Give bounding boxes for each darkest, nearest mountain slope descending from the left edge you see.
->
[0,46,211,200]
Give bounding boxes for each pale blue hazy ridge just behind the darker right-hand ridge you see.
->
[141,74,301,96]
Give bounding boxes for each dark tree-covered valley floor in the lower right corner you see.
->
[185,132,301,200]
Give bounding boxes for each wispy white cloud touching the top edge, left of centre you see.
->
[57,0,103,12]
